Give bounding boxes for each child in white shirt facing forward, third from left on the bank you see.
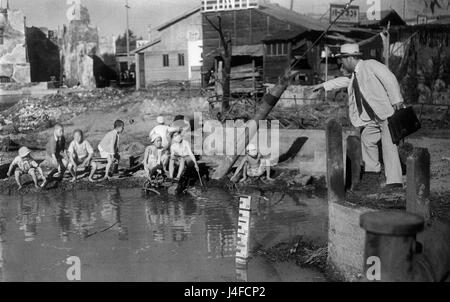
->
[67,129,97,182]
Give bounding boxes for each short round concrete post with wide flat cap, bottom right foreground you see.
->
[360,211,424,282]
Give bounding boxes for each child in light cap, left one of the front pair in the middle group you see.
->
[143,135,168,178]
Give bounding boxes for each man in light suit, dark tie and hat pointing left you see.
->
[313,44,404,188]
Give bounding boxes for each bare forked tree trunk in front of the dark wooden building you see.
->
[205,15,232,113]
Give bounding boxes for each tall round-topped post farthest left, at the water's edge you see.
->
[326,119,345,203]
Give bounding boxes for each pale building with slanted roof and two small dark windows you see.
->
[134,7,202,89]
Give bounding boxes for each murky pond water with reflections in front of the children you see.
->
[0,188,328,282]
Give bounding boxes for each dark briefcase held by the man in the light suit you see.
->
[388,107,422,145]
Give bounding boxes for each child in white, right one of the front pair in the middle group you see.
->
[169,131,199,180]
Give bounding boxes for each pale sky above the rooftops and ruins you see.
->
[0,0,450,39]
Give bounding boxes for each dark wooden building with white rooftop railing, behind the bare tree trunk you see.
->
[202,0,356,87]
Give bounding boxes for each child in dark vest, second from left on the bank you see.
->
[41,124,68,188]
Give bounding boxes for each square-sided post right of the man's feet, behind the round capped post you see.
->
[406,148,431,222]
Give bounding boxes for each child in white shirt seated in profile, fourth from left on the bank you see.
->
[98,120,125,180]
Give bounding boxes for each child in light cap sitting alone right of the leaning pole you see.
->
[231,144,274,182]
